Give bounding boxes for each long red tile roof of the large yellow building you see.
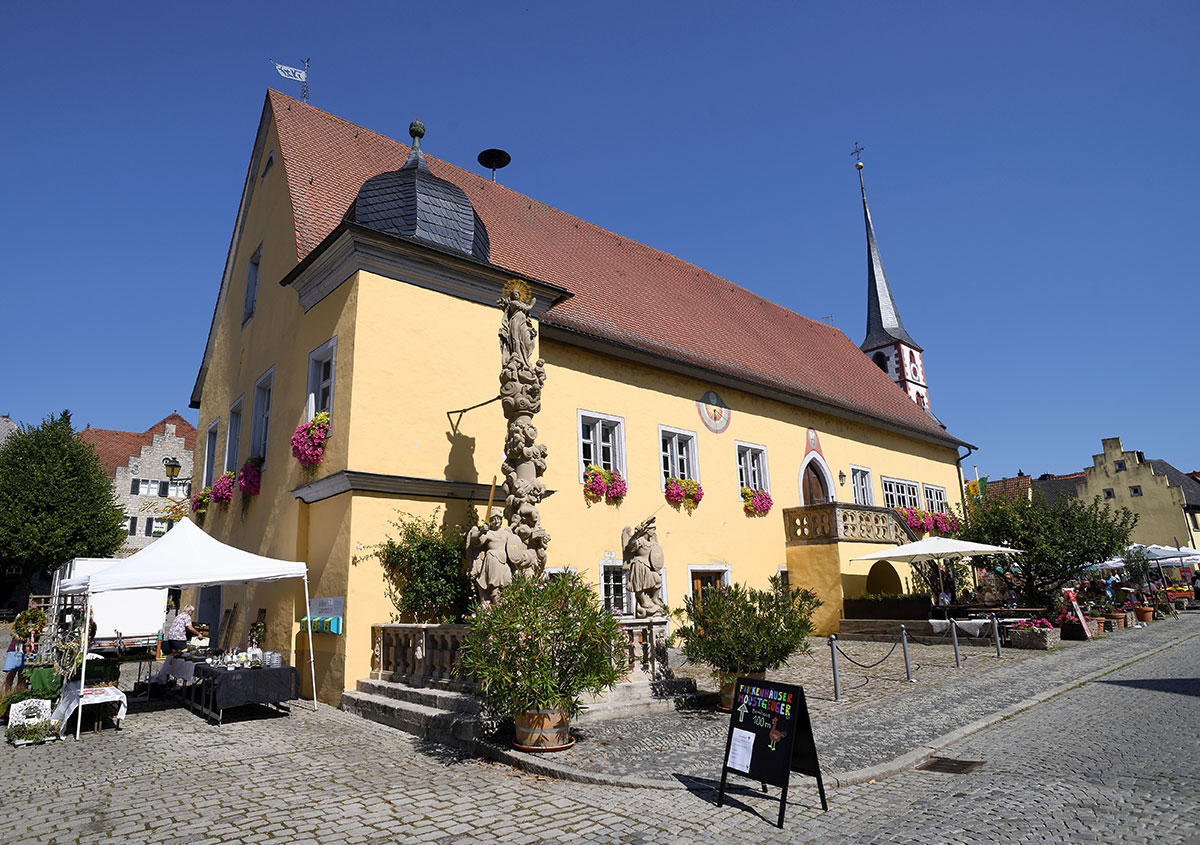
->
[268,91,958,443]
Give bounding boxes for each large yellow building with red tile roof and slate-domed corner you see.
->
[192,91,966,703]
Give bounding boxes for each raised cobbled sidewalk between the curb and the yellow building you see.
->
[556,615,1200,779]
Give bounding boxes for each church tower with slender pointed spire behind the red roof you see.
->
[854,161,932,414]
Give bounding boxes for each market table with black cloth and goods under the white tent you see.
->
[167,649,300,725]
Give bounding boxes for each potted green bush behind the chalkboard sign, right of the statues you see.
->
[671,575,821,711]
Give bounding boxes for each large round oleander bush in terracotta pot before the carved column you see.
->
[455,573,629,751]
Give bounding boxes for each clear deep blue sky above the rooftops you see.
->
[0,0,1200,477]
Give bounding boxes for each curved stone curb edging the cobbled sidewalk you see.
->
[472,619,1200,790]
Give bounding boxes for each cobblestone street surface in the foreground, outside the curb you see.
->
[7,615,1200,845]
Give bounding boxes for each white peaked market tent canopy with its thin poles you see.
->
[59,520,317,739]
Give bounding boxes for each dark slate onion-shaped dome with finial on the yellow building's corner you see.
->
[346,120,491,262]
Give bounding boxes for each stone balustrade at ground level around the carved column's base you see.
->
[371,617,670,684]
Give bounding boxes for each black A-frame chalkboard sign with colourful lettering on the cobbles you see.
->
[716,678,829,827]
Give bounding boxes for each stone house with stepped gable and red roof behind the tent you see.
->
[79,413,196,557]
